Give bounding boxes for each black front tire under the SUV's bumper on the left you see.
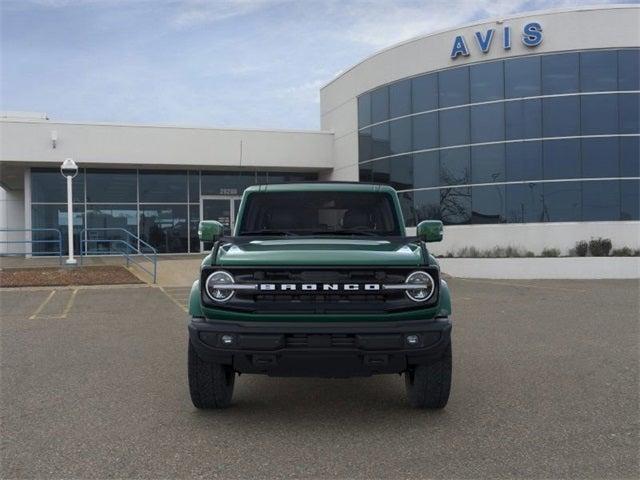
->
[189,341,236,409]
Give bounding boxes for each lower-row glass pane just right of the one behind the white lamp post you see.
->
[87,204,138,254]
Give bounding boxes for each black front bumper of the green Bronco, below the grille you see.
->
[189,318,451,377]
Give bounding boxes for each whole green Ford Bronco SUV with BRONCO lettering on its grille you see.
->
[189,183,451,408]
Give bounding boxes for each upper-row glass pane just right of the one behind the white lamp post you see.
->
[87,169,138,203]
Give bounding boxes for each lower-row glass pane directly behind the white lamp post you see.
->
[31,203,84,255]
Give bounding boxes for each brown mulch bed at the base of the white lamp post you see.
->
[0,265,143,287]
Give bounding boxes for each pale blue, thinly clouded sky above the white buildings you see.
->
[0,0,637,129]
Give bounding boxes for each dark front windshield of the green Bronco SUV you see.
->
[238,191,400,236]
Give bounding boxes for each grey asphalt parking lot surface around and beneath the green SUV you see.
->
[0,279,640,479]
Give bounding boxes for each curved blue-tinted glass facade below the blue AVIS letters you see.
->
[358,49,640,226]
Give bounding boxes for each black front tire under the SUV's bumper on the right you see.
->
[404,344,451,408]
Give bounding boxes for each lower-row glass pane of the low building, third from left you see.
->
[140,205,189,253]
